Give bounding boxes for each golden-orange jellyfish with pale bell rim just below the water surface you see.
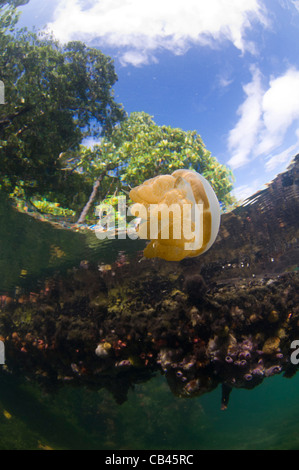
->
[130,170,220,261]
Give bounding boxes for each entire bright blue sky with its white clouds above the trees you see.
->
[20,0,299,199]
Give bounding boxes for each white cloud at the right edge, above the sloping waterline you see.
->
[228,68,299,171]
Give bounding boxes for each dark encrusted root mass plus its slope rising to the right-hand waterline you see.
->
[0,156,299,409]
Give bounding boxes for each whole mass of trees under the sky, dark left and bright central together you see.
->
[0,0,233,219]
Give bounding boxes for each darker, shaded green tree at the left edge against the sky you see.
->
[0,5,125,195]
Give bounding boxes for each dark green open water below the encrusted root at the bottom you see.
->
[0,370,299,450]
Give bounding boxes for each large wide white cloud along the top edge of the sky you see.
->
[48,0,267,65]
